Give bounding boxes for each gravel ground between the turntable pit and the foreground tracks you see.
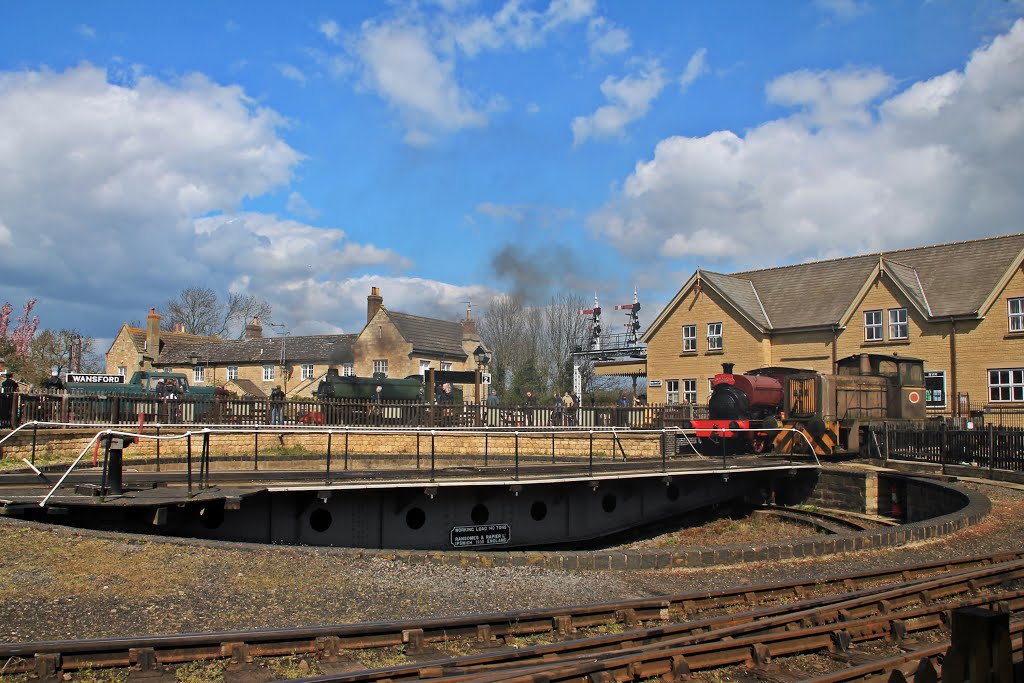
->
[0,482,1024,642]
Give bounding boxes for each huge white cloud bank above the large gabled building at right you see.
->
[590,20,1024,268]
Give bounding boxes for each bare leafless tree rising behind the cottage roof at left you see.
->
[163,287,271,338]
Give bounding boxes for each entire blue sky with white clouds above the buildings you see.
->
[0,0,1024,340]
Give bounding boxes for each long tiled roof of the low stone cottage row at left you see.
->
[156,332,356,366]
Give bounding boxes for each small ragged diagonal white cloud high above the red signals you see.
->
[572,60,665,144]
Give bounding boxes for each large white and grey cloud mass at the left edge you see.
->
[0,65,302,317]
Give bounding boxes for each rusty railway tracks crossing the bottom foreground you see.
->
[0,553,1024,682]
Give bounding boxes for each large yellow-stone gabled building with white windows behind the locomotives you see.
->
[642,234,1024,411]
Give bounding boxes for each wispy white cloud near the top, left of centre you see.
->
[359,24,486,145]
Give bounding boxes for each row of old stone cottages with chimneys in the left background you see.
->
[106,287,489,398]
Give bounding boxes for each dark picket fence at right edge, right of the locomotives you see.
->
[873,422,1024,472]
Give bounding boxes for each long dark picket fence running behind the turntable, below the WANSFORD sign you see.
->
[0,394,708,429]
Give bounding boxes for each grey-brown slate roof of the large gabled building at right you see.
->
[644,234,1024,341]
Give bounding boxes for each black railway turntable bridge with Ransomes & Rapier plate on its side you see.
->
[0,429,819,550]
